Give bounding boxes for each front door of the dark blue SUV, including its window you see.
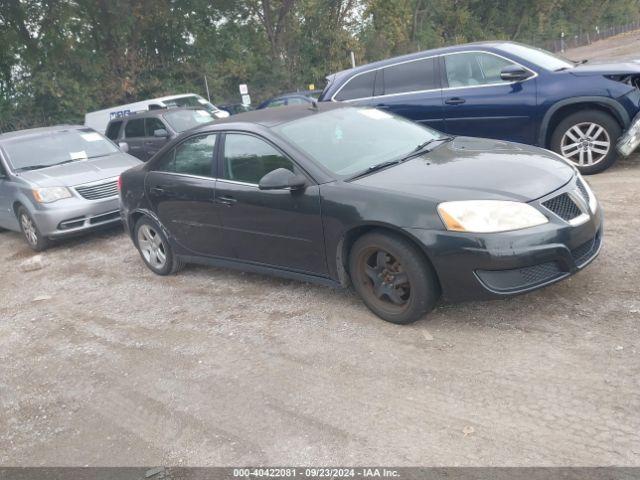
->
[441,52,536,143]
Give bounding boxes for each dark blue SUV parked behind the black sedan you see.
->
[320,42,640,174]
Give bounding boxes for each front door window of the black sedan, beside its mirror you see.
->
[224,133,294,185]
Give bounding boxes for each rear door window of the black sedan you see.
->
[155,133,217,177]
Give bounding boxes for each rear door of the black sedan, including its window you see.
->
[145,133,232,257]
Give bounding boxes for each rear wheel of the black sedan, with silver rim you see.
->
[134,217,184,275]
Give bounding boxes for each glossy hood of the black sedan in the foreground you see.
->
[353,137,574,202]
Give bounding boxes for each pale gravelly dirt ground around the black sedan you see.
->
[0,37,640,466]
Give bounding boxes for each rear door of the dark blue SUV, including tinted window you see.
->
[371,57,445,130]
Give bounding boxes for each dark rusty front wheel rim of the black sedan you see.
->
[359,248,411,310]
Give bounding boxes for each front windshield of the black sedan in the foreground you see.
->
[274,107,442,177]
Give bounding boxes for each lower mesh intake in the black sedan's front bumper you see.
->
[476,262,566,293]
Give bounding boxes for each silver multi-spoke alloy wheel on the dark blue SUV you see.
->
[560,122,611,167]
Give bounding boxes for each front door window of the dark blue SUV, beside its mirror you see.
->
[444,52,514,87]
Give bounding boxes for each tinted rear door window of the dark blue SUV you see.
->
[376,58,440,95]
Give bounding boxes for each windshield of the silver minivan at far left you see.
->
[3,128,119,171]
